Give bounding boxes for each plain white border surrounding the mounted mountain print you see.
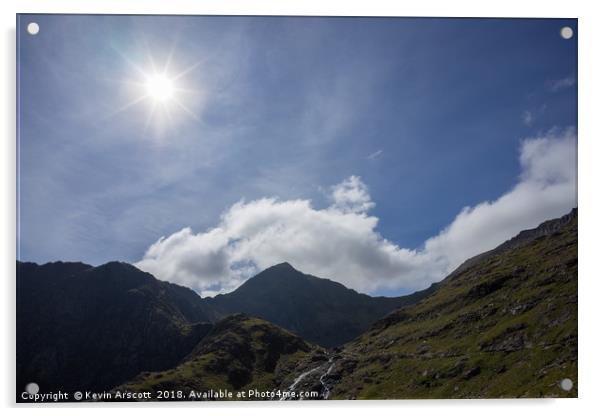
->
[0,0,602,416]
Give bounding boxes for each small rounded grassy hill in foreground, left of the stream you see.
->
[113,314,317,400]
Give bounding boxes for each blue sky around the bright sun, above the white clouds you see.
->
[18,15,577,294]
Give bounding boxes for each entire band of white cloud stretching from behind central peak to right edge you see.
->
[136,129,577,295]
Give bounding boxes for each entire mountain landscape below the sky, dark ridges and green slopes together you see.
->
[17,210,577,399]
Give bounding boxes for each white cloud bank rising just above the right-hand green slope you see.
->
[425,129,577,272]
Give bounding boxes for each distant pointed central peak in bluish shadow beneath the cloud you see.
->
[205,263,436,347]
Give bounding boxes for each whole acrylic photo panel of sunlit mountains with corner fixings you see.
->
[16,14,578,402]
